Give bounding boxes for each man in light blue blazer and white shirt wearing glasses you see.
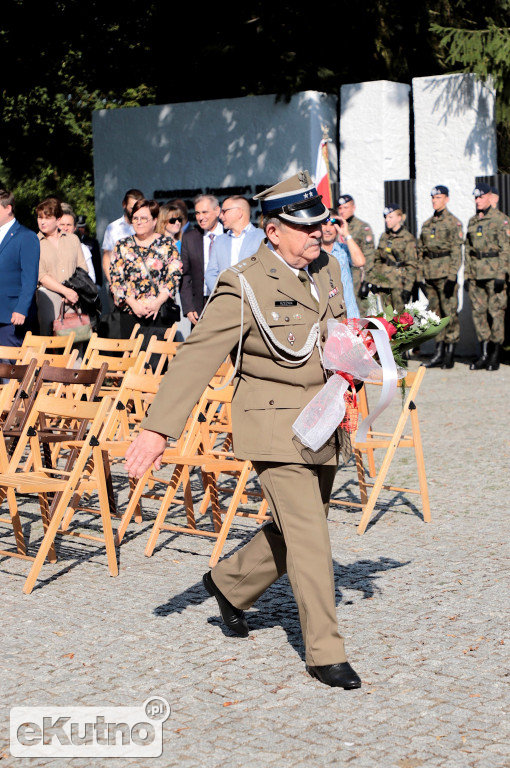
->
[205,195,264,293]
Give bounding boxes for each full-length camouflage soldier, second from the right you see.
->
[418,184,464,368]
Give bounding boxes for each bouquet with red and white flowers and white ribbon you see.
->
[292,301,449,451]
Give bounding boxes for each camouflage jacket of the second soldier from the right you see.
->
[418,208,464,282]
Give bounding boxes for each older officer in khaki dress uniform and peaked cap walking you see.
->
[126,171,361,689]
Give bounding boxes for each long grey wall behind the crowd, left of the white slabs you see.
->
[93,91,337,241]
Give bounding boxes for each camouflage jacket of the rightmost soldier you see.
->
[465,208,510,280]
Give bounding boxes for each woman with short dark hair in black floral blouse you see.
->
[110,199,182,339]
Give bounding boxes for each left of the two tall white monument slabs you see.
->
[339,80,410,244]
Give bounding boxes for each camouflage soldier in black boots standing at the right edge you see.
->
[465,183,510,371]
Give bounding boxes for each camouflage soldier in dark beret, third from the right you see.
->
[365,203,417,312]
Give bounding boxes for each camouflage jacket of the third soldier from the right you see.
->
[365,227,418,291]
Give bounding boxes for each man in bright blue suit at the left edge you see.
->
[0,189,40,347]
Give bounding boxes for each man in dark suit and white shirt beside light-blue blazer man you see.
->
[180,195,223,326]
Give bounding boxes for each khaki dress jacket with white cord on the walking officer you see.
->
[143,243,351,464]
